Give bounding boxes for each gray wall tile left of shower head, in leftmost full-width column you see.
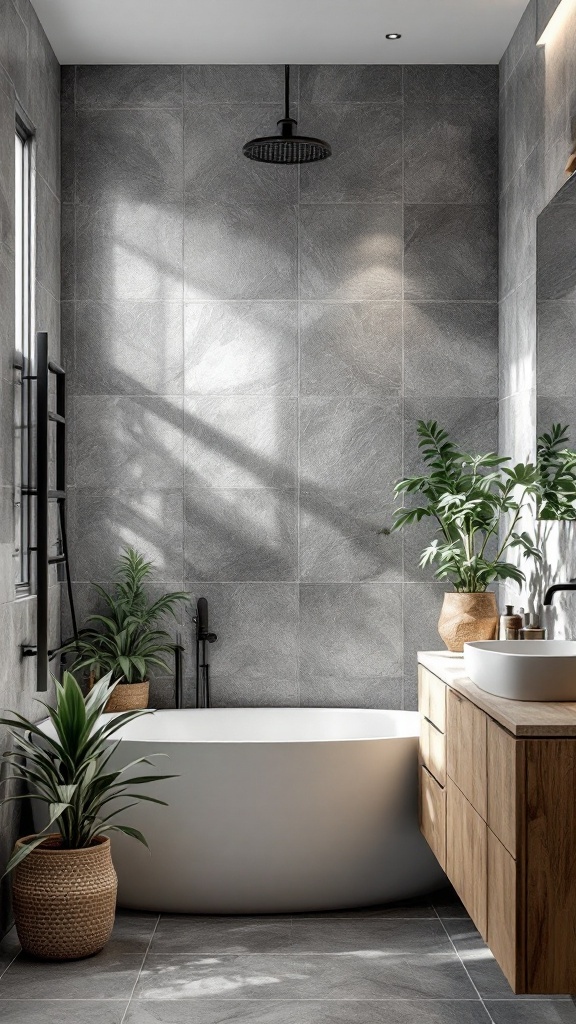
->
[75,110,183,206]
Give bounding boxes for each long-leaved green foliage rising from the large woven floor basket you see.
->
[0,672,175,873]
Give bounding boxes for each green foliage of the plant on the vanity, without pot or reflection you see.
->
[382,420,541,593]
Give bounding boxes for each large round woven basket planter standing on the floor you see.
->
[12,835,118,961]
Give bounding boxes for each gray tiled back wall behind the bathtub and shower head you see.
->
[63,66,498,708]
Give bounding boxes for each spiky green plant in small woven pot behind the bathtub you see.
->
[68,548,190,712]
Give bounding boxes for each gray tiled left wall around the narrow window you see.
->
[0,0,60,935]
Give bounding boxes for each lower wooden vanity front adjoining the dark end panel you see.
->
[488,828,526,992]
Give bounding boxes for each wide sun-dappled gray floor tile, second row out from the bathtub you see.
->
[134,946,475,999]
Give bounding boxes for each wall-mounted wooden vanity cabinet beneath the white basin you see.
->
[418,655,576,995]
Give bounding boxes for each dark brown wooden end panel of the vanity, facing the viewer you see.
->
[526,738,576,995]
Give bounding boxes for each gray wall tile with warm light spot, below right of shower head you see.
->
[300,204,402,299]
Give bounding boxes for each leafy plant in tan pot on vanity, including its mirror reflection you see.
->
[381,420,576,651]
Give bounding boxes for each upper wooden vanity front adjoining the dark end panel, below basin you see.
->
[487,718,525,858]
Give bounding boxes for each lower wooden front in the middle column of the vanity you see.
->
[446,777,488,941]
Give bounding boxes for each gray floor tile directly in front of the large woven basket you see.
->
[0,950,142,999]
